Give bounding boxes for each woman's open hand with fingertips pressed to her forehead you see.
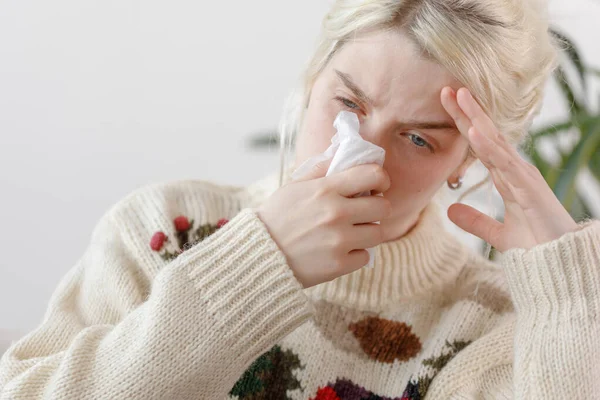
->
[441,87,578,252]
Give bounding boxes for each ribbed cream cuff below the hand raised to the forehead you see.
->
[503,221,600,315]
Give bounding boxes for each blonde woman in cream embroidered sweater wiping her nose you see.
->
[0,0,600,400]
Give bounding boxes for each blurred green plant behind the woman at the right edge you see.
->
[525,29,600,220]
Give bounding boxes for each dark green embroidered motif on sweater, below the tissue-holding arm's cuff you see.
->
[229,346,303,400]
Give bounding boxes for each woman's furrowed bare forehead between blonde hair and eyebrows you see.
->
[330,31,461,112]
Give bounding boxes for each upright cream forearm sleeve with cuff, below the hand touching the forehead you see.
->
[504,222,600,399]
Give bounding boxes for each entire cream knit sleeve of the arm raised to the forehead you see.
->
[426,221,600,400]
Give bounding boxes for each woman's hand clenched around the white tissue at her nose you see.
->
[257,163,391,288]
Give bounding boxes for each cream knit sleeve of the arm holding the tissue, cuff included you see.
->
[0,205,313,400]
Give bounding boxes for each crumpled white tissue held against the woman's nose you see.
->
[292,111,385,268]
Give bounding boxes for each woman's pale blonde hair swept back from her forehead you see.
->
[279,0,558,186]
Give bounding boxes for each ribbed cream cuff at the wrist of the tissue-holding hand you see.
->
[180,209,314,351]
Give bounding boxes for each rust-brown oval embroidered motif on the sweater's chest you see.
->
[348,317,421,364]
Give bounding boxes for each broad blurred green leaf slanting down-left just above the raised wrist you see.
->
[553,116,600,209]
